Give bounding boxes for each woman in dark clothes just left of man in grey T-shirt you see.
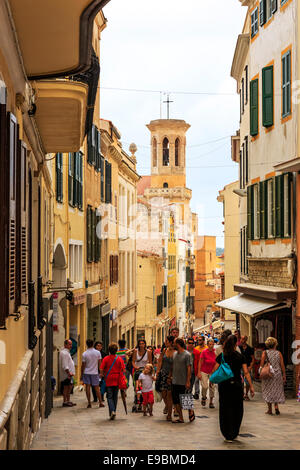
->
[155,335,175,421]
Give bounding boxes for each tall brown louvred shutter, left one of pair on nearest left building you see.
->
[8,113,18,314]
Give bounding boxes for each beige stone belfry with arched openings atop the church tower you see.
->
[147,119,190,188]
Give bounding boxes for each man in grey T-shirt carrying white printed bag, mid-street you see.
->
[170,338,195,423]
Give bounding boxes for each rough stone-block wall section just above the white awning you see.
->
[248,258,295,288]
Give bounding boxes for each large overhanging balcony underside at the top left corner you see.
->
[7,0,109,80]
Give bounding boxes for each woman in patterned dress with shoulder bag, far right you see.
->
[260,337,286,415]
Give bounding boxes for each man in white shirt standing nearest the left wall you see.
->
[59,339,76,406]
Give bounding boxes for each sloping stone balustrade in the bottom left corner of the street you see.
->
[0,327,46,450]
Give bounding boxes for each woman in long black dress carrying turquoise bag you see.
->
[213,335,254,442]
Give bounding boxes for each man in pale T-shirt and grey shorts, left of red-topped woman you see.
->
[81,339,104,408]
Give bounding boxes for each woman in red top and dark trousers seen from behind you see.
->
[100,343,125,420]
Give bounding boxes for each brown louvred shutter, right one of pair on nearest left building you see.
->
[16,140,27,306]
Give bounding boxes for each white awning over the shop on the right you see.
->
[216,294,282,315]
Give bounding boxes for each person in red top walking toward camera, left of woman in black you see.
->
[198,338,216,408]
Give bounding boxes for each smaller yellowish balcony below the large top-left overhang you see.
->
[34,80,89,153]
